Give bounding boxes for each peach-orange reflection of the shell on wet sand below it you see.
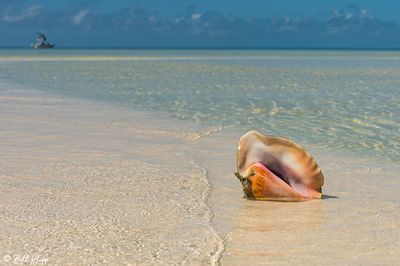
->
[222,200,325,264]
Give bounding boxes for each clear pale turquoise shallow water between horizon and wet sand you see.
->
[0,50,400,161]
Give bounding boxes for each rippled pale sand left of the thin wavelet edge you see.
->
[0,87,222,265]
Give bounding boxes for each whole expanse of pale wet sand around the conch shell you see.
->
[0,85,400,265]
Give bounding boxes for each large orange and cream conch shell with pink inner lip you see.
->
[235,131,324,201]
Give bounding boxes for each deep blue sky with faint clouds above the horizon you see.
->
[0,0,400,48]
